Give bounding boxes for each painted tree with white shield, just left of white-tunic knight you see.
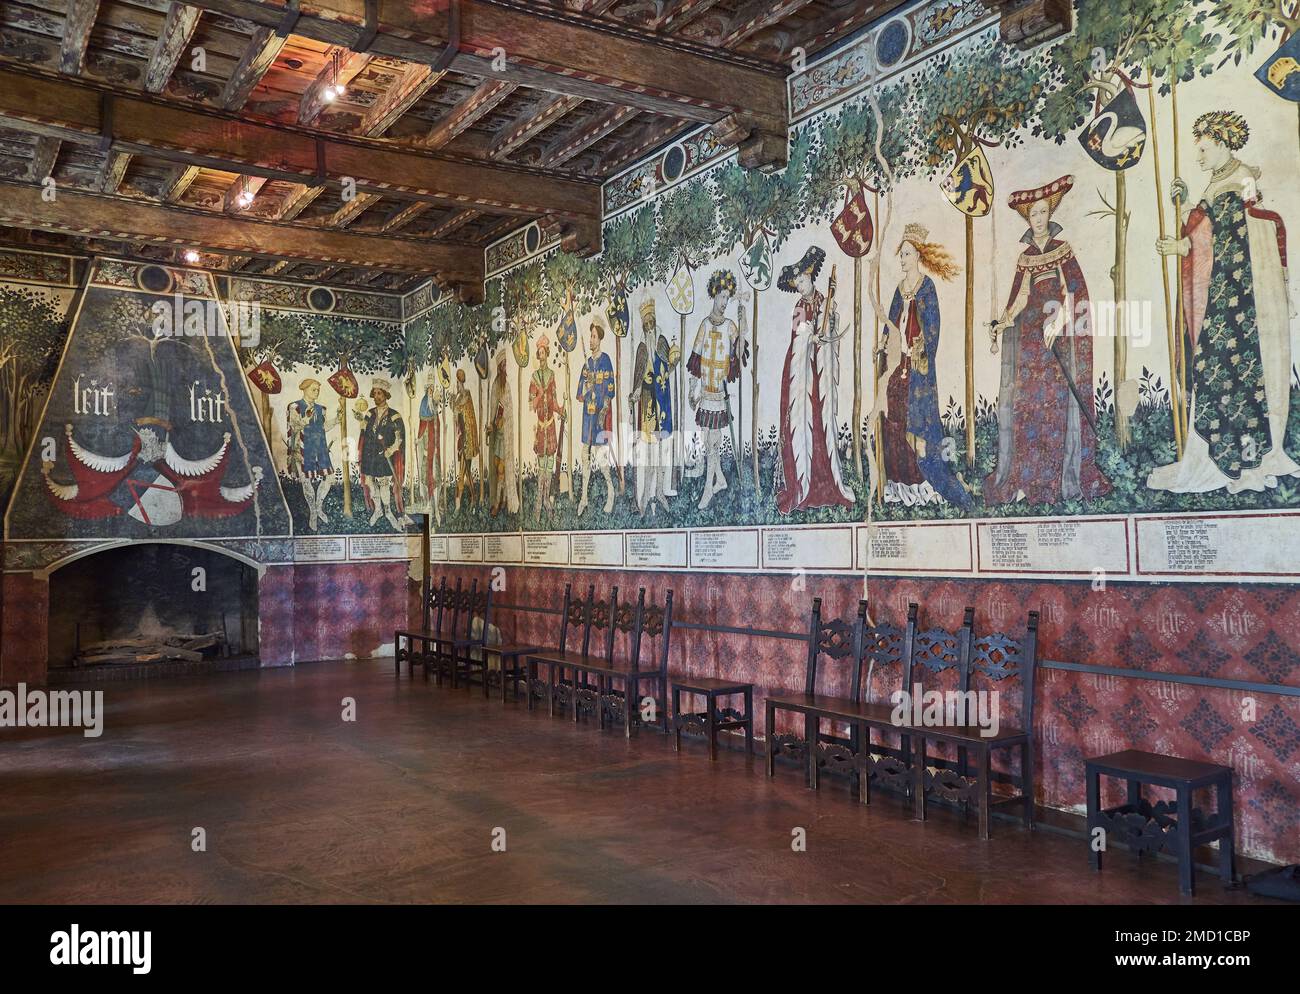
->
[651,177,722,488]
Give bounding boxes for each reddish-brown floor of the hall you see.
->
[0,660,1274,903]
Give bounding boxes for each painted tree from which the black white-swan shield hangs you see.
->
[1034,0,1218,450]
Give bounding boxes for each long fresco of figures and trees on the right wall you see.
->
[418,0,1300,574]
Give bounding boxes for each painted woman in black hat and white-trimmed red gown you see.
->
[776,246,854,515]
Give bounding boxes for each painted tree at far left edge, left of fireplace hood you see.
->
[0,287,68,485]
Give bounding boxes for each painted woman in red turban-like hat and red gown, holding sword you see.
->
[987,175,1110,504]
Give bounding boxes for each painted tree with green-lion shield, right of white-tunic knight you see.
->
[712,127,811,498]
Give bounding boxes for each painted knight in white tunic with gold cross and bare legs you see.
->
[686,269,745,511]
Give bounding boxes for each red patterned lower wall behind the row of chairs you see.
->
[423,567,1300,863]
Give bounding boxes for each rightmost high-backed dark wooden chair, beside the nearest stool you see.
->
[910,608,1039,839]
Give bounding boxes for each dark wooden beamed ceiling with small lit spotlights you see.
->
[0,0,902,294]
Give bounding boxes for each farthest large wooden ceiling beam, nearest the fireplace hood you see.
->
[0,179,484,282]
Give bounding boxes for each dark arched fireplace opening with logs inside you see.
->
[49,543,257,674]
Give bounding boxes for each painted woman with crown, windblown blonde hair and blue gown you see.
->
[876,223,971,507]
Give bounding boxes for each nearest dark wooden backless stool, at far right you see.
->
[1087,748,1234,894]
